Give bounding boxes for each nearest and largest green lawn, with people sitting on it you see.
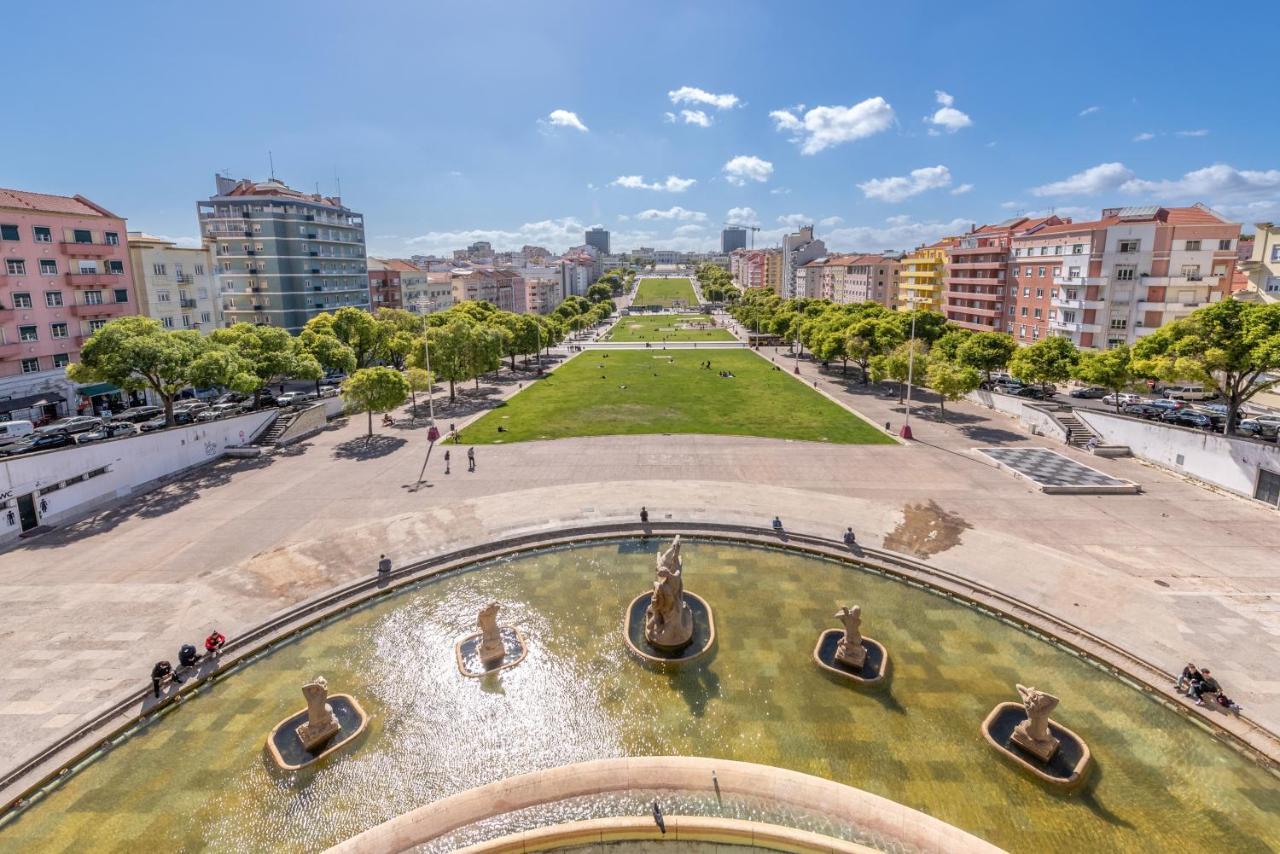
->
[462,350,892,444]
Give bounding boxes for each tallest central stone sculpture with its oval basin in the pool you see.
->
[623,534,716,663]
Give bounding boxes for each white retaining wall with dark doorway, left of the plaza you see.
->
[0,411,274,543]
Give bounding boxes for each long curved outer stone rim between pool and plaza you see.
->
[0,521,1280,819]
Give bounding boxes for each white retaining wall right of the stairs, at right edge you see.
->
[1075,410,1280,498]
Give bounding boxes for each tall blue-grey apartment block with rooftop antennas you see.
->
[196,175,370,332]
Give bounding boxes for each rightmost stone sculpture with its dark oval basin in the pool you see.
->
[982,685,1091,787]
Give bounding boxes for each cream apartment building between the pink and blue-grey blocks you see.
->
[128,232,223,335]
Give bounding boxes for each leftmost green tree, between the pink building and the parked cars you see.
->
[67,316,207,425]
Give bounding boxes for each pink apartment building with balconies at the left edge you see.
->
[0,189,137,421]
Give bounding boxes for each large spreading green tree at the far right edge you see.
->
[1133,300,1280,430]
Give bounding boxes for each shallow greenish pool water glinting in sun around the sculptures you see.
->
[0,540,1280,851]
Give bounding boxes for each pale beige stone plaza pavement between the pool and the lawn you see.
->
[0,352,1280,759]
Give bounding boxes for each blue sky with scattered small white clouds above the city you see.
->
[0,0,1280,255]
